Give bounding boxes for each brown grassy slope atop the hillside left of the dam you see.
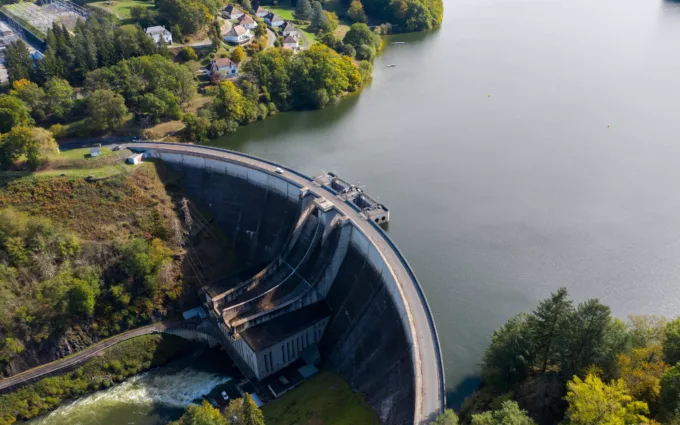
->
[0,159,175,241]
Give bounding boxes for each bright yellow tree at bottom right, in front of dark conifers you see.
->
[566,373,650,425]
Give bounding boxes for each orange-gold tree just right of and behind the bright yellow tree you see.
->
[618,344,667,412]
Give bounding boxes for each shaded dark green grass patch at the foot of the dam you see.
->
[262,371,379,425]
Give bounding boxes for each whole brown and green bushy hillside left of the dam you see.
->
[0,150,202,375]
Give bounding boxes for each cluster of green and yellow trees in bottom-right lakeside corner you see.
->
[437,288,680,425]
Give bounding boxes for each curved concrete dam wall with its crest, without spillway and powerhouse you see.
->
[139,143,445,425]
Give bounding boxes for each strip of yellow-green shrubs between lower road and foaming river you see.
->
[0,335,190,425]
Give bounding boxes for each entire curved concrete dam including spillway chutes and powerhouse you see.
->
[128,142,445,425]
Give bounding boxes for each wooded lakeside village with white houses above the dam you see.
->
[0,0,382,149]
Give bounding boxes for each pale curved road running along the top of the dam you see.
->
[128,142,445,424]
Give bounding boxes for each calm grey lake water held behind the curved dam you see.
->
[211,0,680,402]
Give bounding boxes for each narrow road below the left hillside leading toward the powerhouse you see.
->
[0,320,183,391]
